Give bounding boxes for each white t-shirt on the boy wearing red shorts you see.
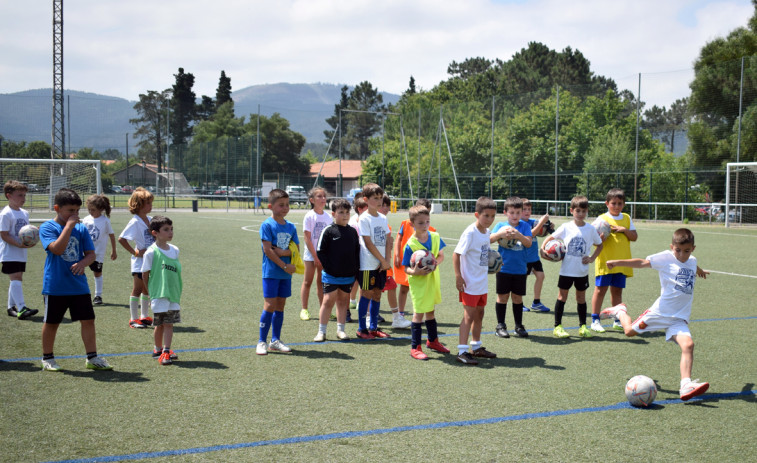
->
[455,222,491,296]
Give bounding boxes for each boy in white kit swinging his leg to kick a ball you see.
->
[600,228,710,400]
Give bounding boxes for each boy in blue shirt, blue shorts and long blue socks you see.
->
[255,188,300,355]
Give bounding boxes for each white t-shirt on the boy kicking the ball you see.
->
[647,250,697,322]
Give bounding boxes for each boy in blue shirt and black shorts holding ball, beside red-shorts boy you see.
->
[489,196,531,338]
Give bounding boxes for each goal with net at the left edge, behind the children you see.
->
[0,158,102,212]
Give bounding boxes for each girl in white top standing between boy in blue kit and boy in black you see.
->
[300,187,334,320]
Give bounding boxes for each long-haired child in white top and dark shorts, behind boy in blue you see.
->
[81,195,118,305]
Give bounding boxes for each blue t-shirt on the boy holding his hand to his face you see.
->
[39,220,95,296]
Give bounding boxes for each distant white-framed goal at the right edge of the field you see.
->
[725,162,757,227]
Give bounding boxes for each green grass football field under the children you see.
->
[0,205,757,462]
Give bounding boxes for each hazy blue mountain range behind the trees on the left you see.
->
[0,83,400,152]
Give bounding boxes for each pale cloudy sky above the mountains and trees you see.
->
[0,0,754,106]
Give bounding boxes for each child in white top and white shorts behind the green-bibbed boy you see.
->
[118,187,155,328]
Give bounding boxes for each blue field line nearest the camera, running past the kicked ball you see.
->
[46,390,757,463]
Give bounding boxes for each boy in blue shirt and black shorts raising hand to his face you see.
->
[39,188,113,371]
